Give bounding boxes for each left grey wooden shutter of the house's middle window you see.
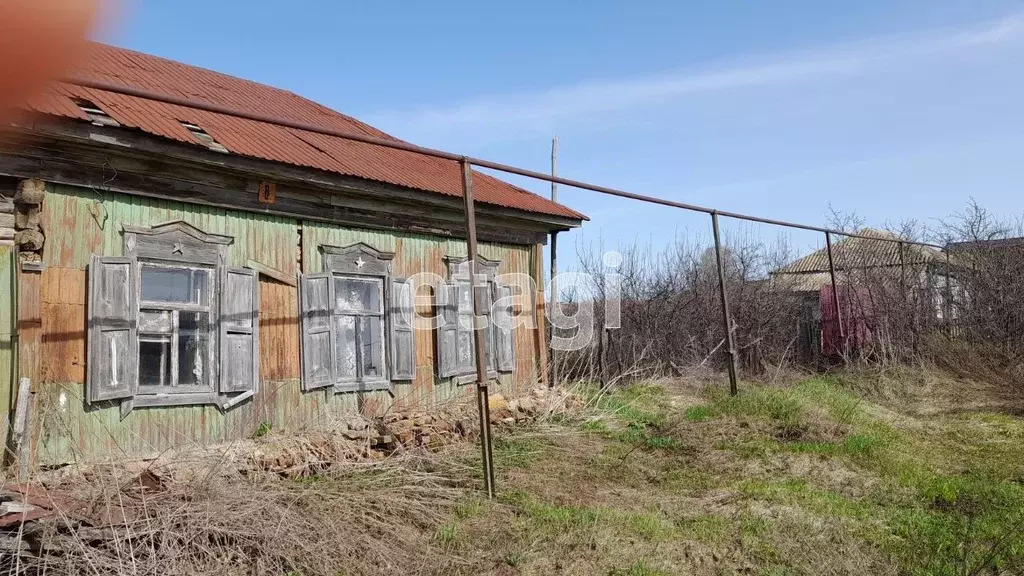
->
[299,274,336,392]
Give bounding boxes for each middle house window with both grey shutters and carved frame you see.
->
[299,239,416,393]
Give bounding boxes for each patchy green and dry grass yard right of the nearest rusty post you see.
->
[436,378,1024,576]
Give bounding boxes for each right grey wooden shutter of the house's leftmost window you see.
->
[218,268,259,394]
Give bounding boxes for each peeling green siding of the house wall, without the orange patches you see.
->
[22,186,538,464]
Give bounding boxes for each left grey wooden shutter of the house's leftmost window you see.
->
[87,254,138,402]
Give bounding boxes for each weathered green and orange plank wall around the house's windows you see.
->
[24,186,543,464]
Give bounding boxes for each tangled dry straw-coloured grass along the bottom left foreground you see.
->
[0,453,472,576]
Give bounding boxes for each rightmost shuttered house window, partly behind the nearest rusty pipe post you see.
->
[437,254,514,383]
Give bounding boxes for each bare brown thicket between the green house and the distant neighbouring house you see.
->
[566,226,800,380]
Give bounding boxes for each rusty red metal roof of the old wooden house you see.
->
[22,43,587,219]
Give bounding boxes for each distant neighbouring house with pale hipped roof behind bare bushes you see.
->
[771,229,964,356]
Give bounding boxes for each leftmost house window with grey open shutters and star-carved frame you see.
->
[87,221,259,415]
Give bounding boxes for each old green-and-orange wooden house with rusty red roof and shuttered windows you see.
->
[0,45,586,464]
